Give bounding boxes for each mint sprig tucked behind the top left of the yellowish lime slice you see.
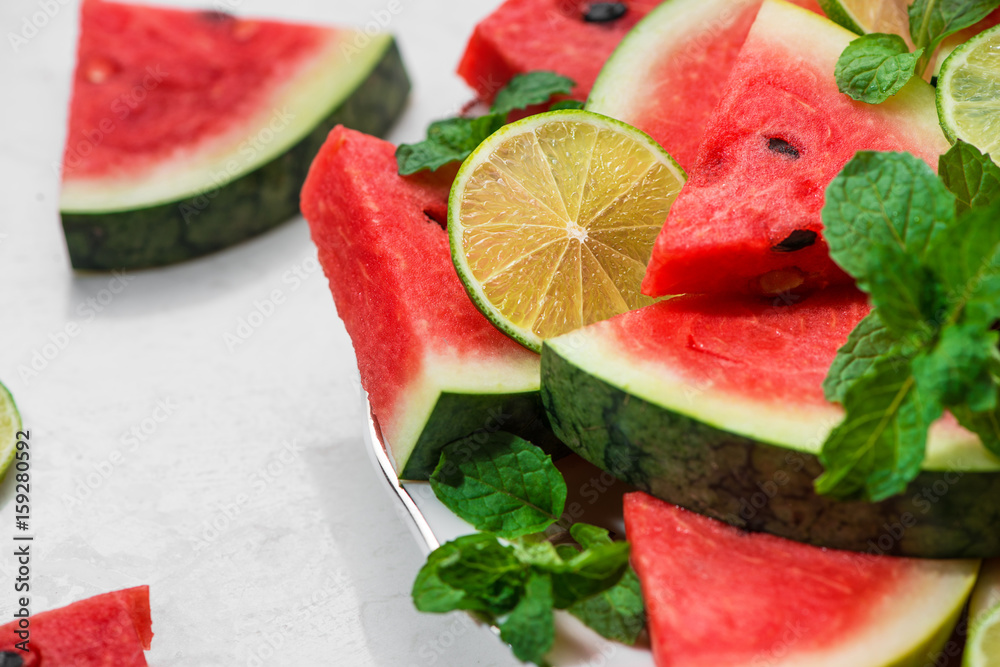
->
[396,72,579,176]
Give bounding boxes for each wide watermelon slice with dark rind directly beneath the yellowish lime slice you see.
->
[542,287,1000,558]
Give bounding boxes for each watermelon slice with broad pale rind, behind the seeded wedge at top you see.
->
[586,0,821,171]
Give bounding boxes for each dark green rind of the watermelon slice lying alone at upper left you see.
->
[61,37,410,271]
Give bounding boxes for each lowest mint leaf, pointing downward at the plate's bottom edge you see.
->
[500,574,556,665]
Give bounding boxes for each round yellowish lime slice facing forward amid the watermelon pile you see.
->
[448,110,685,350]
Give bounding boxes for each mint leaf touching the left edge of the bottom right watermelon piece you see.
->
[568,567,646,646]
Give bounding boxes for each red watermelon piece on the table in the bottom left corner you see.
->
[0,586,153,667]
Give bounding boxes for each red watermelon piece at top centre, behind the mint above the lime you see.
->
[458,0,661,102]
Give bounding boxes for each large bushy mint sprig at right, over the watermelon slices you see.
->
[816,144,1000,501]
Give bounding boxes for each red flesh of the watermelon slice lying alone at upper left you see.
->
[64,0,342,178]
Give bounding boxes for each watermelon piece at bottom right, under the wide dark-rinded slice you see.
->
[624,493,979,667]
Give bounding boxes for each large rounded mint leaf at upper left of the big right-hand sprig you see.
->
[823,151,955,291]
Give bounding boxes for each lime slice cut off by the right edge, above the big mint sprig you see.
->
[937,26,1000,157]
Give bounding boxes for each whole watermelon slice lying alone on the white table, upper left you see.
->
[60,0,409,269]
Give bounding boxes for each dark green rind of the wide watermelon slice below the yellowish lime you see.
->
[542,342,1000,558]
